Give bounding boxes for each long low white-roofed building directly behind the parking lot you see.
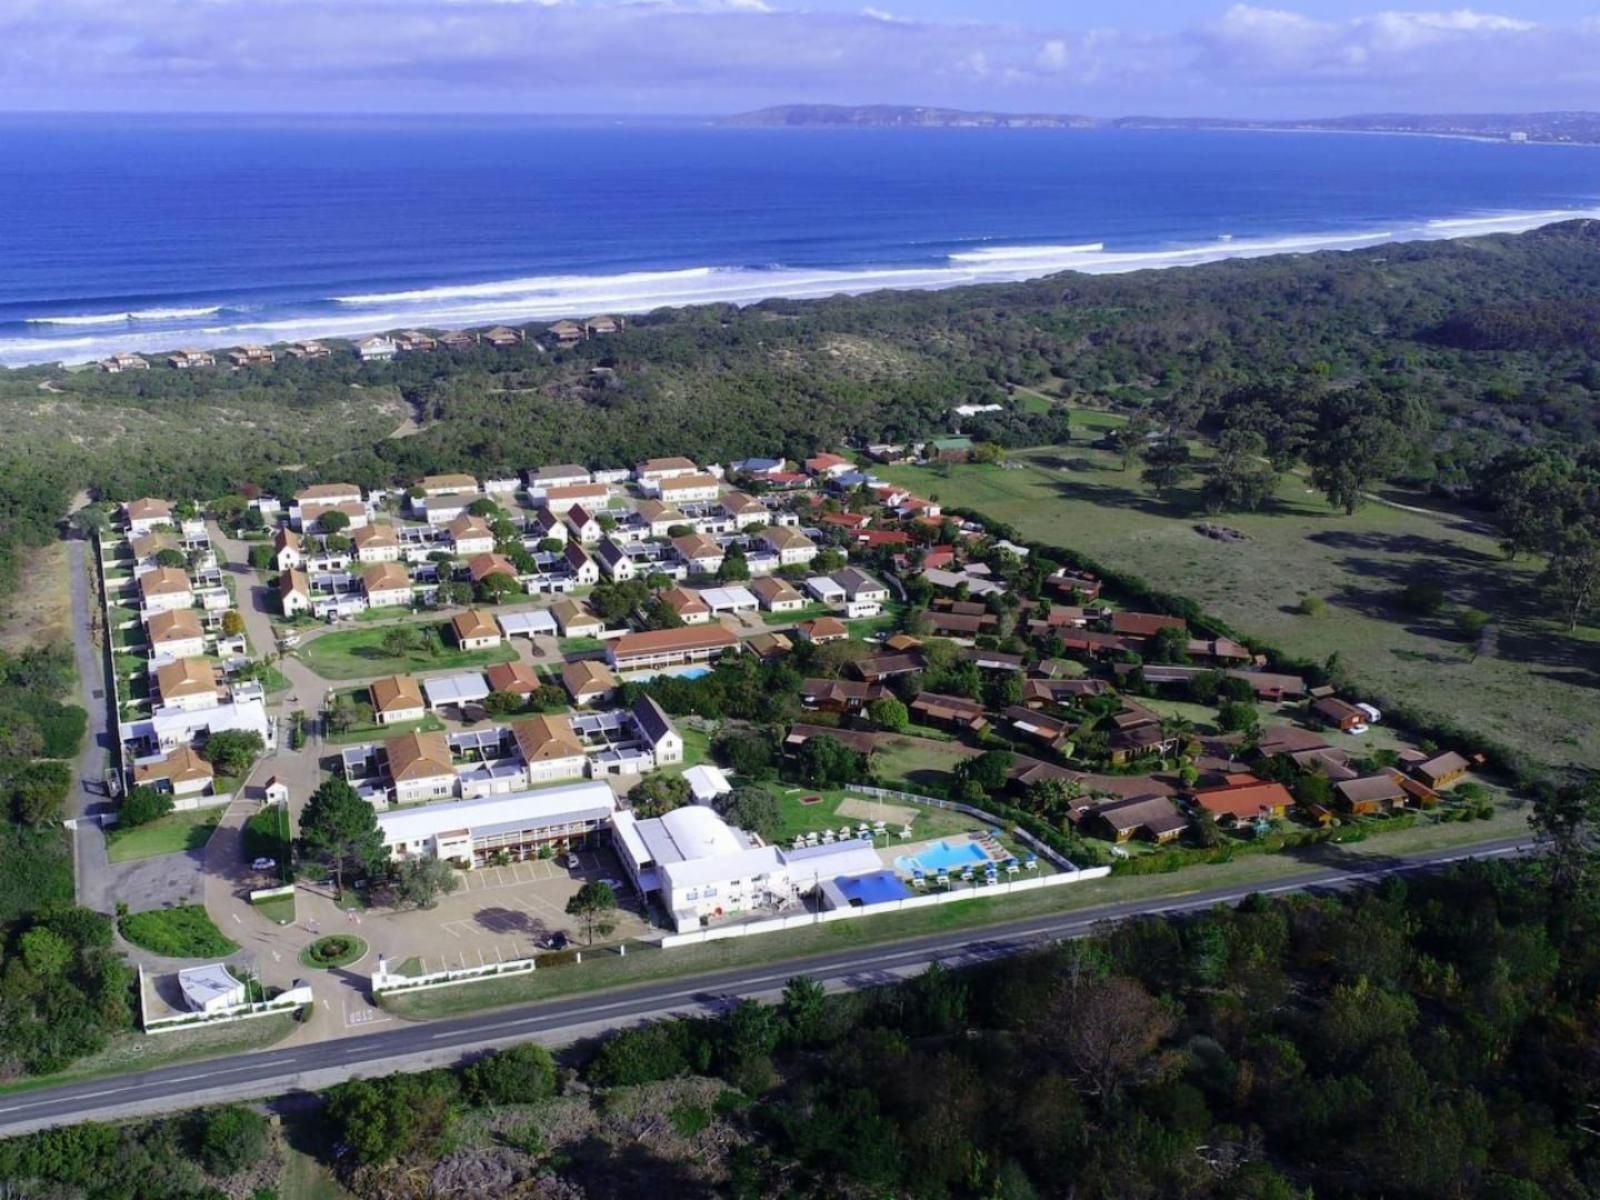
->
[378,782,616,867]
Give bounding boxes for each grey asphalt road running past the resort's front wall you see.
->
[0,837,1531,1134]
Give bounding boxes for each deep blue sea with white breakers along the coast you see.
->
[0,117,1600,363]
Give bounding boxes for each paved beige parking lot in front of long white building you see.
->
[366,850,650,973]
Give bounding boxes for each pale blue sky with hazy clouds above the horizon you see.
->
[0,0,1600,118]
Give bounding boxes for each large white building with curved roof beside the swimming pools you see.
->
[611,805,883,933]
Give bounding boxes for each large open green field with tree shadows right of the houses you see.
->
[880,448,1600,768]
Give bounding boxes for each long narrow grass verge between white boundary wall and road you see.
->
[382,810,1526,1021]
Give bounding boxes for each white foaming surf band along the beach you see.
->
[0,206,1600,370]
